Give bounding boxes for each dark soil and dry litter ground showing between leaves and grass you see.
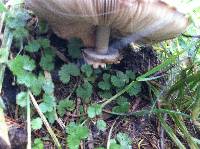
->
[3,32,200,149]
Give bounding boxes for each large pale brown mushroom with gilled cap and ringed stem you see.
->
[26,0,188,68]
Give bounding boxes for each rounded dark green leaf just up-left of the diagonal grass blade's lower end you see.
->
[76,82,93,100]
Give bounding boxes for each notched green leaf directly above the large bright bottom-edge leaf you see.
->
[57,99,75,116]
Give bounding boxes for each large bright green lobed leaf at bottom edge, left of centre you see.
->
[66,123,89,149]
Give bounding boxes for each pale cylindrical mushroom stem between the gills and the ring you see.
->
[96,26,110,54]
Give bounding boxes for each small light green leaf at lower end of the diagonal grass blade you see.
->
[87,104,102,118]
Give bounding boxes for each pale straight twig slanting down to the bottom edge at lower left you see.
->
[28,91,62,149]
